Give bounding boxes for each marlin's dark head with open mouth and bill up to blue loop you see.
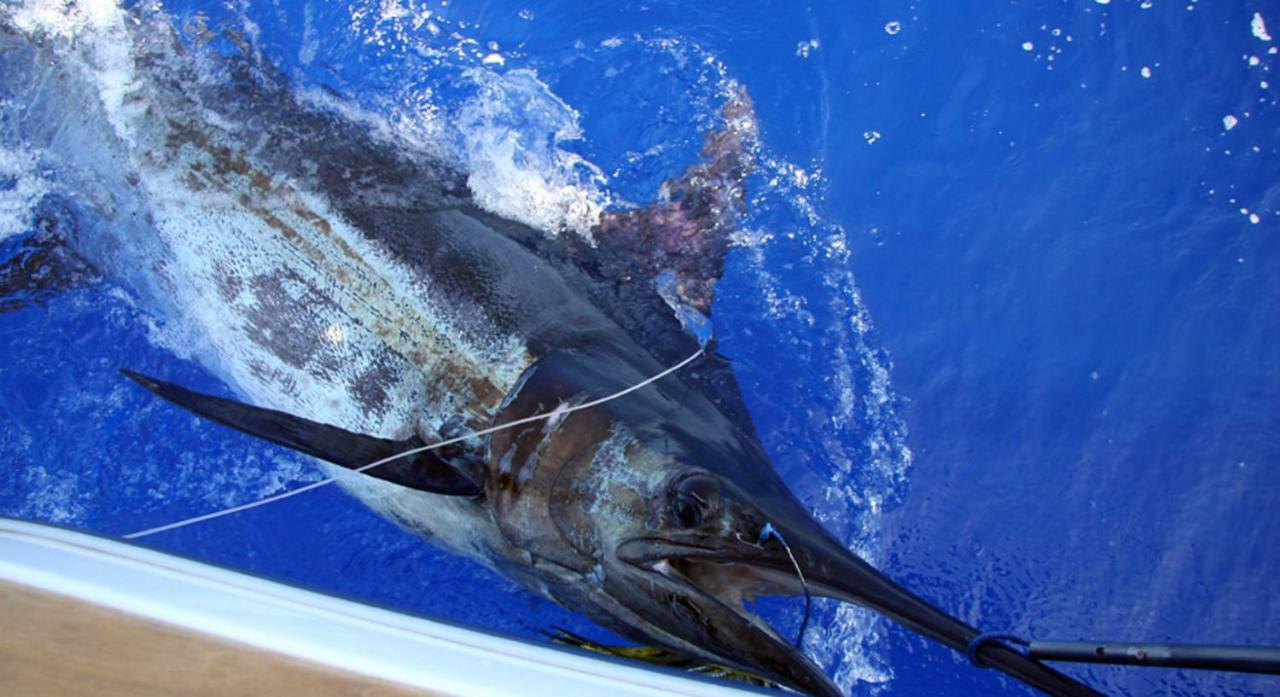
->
[509,350,974,697]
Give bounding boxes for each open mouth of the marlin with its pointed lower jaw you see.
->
[617,537,844,697]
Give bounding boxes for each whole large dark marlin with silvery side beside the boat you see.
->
[5,6,1093,697]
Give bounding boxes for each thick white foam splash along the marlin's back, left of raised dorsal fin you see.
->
[335,0,623,237]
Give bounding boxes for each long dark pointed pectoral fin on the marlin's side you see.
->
[120,370,480,496]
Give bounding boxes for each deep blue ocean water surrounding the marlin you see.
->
[0,0,1280,694]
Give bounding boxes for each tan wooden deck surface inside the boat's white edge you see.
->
[0,582,439,697]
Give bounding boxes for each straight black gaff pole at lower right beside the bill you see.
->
[1025,641,1280,675]
